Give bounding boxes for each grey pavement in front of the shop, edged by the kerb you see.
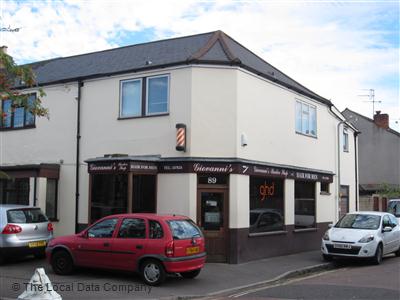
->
[0,251,331,299]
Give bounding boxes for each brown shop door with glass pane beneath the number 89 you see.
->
[197,189,229,262]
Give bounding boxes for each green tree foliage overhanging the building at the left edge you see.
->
[0,48,49,178]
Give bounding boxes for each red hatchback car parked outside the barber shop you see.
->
[46,214,206,285]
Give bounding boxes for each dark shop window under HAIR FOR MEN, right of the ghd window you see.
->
[294,181,316,229]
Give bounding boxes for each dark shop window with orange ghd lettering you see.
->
[250,177,284,233]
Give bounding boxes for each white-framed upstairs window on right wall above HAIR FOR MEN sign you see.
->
[296,101,317,137]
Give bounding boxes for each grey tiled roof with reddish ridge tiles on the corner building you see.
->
[25,31,331,105]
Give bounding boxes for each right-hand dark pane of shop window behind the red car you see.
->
[132,175,157,213]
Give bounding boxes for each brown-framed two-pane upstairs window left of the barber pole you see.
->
[119,75,169,118]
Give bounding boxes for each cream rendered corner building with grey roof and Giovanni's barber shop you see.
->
[0,31,358,263]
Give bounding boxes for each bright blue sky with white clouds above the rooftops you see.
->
[0,0,400,131]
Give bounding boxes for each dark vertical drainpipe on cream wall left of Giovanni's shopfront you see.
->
[75,80,83,233]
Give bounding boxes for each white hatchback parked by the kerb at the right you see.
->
[321,212,400,264]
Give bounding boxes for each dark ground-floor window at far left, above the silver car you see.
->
[0,178,29,205]
